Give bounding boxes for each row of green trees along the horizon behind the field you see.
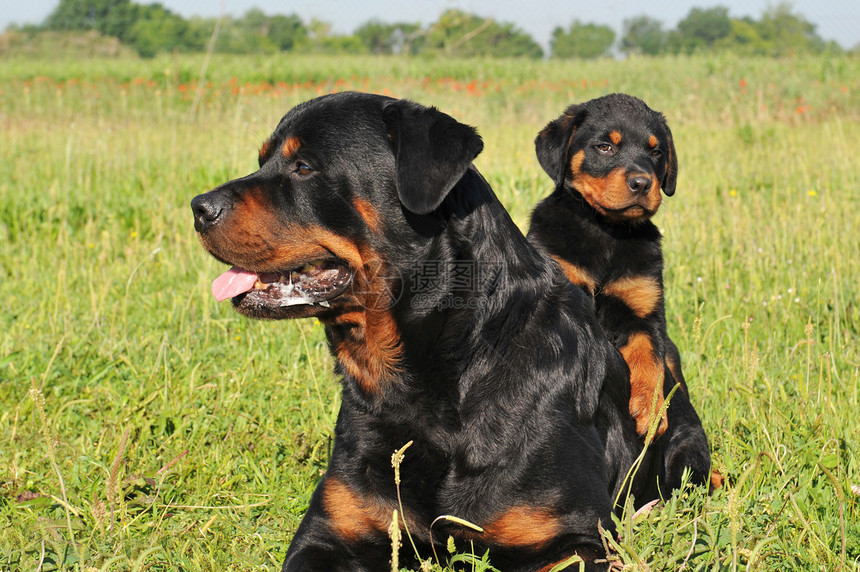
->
[13,0,842,59]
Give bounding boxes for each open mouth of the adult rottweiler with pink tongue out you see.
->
[212,259,352,308]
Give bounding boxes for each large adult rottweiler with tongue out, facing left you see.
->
[192,93,650,572]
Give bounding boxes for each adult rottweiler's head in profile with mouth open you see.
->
[191,93,483,319]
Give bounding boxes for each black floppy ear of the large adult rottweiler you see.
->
[383,100,484,214]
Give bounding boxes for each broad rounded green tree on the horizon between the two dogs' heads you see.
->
[427,9,543,58]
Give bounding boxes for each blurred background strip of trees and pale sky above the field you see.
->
[0,0,860,58]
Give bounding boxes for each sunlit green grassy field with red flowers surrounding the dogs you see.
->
[0,52,860,572]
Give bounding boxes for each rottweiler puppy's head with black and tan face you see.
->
[535,94,678,223]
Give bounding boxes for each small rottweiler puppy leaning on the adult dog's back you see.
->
[528,94,719,492]
